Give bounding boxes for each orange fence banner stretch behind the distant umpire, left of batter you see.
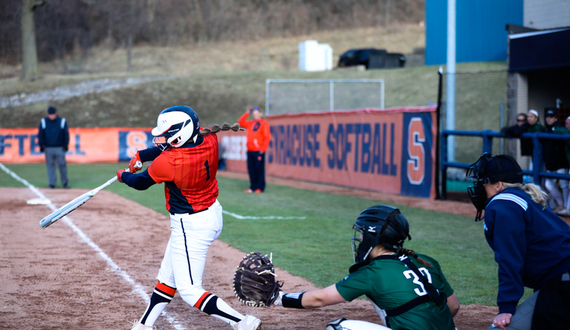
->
[0,127,153,164]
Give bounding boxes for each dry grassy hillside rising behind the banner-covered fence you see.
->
[0,25,426,127]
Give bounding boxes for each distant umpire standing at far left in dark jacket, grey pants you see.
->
[38,107,69,189]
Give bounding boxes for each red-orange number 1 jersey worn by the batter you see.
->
[148,134,218,213]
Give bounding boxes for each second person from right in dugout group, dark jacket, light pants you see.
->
[542,108,569,215]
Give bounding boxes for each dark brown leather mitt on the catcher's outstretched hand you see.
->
[234,252,283,307]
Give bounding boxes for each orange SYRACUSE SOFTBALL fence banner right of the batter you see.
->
[218,107,437,199]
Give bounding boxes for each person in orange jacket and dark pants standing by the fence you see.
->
[238,107,271,193]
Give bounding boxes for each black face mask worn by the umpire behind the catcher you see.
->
[465,153,523,221]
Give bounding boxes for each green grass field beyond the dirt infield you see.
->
[0,164,520,305]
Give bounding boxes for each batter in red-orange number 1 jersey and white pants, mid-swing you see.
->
[117,106,261,330]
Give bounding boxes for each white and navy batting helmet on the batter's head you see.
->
[151,105,200,151]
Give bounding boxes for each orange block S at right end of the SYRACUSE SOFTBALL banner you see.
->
[406,118,426,185]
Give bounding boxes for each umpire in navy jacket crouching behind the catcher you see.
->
[467,153,570,330]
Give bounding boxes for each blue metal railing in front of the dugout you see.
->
[440,130,570,199]
